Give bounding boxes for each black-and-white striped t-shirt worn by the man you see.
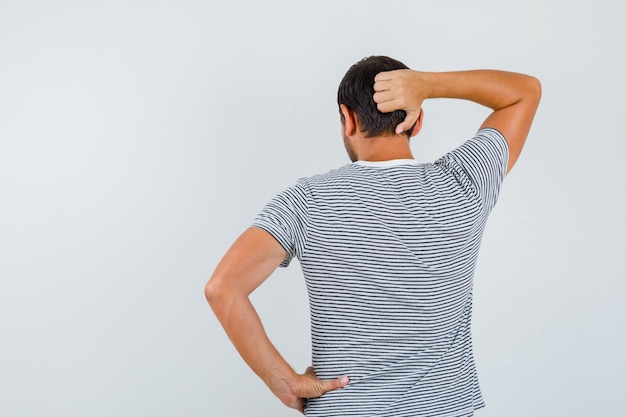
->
[253,129,508,417]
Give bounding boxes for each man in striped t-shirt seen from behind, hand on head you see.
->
[206,57,541,417]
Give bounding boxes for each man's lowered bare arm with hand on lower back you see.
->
[205,227,348,412]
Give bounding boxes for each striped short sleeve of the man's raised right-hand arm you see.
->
[435,128,509,213]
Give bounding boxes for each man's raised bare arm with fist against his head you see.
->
[374,70,541,173]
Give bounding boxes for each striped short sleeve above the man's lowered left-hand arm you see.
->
[252,182,308,267]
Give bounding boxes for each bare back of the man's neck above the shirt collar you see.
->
[354,134,413,162]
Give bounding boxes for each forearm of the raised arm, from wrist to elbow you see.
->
[416,70,539,110]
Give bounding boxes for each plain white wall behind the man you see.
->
[0,0,626,417]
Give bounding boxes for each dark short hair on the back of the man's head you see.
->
[337,56,410,137]
